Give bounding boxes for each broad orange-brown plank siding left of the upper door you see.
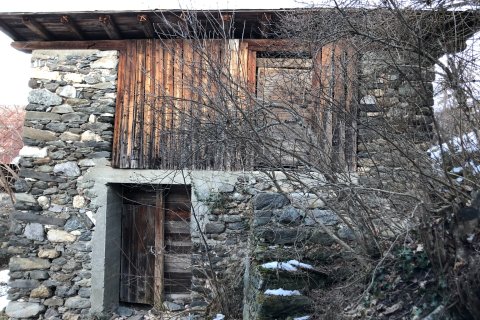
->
[112,40,254,170]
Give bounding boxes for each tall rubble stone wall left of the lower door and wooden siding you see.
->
[6,50,118,319]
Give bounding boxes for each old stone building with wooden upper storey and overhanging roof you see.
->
[0,11,476,319]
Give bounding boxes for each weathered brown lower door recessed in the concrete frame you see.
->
[120,187,192,305]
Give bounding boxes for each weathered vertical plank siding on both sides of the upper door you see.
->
[113,40,357,170]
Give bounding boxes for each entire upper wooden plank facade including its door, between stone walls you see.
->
[112,39,356,170]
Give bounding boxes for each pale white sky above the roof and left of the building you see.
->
[0,0,311,105]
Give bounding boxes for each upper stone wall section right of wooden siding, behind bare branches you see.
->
[357,50,435,185]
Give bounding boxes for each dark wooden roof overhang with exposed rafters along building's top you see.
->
[0,8,480,56]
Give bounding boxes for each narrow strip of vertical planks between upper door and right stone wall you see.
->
[311,42,358,170]
